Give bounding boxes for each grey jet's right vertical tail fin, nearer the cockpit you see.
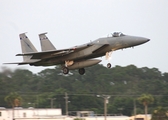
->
[39,33,56,51]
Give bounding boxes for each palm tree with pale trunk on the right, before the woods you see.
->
[138,94,154,120]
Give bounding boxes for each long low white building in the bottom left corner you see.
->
[0,107,63,120]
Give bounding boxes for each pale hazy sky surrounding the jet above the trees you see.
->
[0,0,168,72]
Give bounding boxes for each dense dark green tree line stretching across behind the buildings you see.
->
[0,64,168,116]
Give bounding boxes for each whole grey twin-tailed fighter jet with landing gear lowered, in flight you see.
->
[5,32,150,75]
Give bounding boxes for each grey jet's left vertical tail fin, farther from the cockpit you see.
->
[19,33,37,61]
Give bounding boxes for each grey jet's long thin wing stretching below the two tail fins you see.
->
[16,45,91,59]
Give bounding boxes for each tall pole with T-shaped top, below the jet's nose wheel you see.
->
[97,95,111,120]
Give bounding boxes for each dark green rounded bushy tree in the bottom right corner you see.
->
[151,107,168,120]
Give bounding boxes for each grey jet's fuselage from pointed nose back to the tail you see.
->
[33,35,149,66]
